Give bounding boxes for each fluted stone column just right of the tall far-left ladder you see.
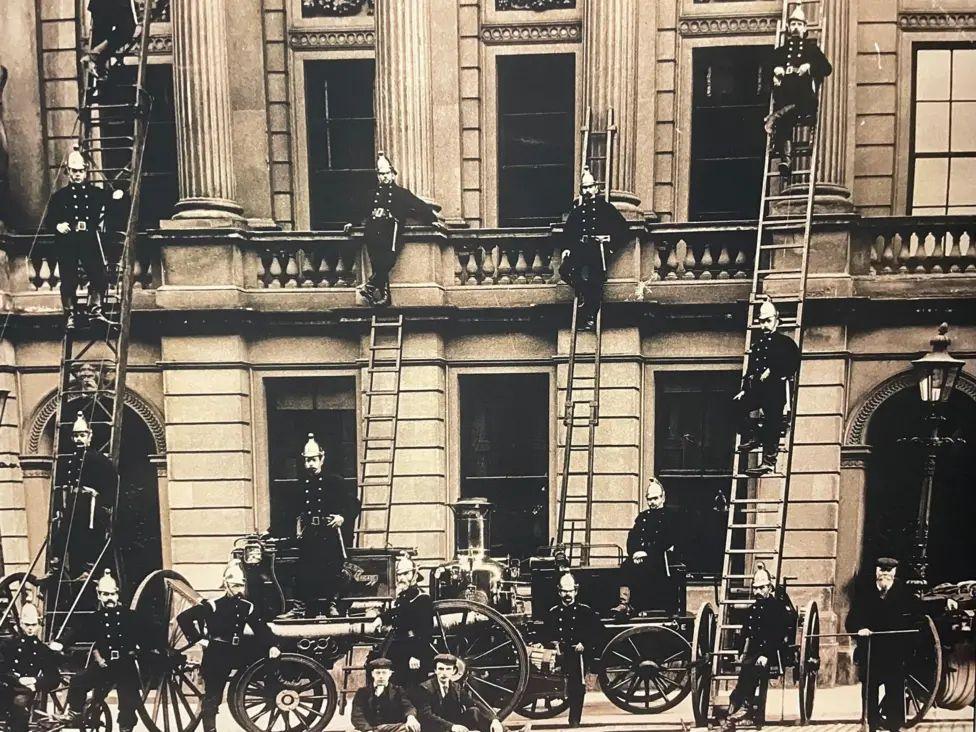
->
[172,0,242,219]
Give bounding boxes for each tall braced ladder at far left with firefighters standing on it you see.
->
[0,0,168,640]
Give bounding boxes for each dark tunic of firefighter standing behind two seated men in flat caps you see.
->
[381,585,434,688]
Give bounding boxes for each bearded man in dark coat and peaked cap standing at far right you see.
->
[845,557,959,732]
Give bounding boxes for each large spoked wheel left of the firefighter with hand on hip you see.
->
[131,569,203,732]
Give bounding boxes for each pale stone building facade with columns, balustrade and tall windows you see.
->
[0,0,976,688]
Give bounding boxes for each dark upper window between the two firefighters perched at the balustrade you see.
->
[498,54,576,226]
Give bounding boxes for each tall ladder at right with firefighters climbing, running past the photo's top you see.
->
[697,0,823,722]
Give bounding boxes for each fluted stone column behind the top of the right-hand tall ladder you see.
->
[816,0,852,211]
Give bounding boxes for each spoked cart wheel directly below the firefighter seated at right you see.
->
[599,625,691,714]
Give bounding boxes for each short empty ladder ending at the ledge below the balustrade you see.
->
[356,315,403,548]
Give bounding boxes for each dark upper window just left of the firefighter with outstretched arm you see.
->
[305,59,378,229]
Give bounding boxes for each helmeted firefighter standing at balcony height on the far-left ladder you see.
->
[47,150,125,328]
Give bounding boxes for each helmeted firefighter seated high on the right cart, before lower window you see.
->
[614,478,678,616]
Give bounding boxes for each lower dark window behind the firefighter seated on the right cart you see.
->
[654,372,738,577]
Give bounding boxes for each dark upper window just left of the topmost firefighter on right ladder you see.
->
[688,46,771,221]
